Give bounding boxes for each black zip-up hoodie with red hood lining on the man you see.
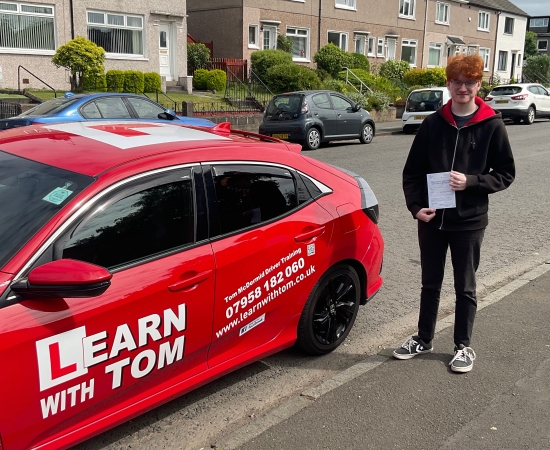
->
[403,97,515,231]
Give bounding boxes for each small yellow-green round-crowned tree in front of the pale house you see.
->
[52,36,105,90]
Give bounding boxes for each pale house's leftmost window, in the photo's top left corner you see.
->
[0,2,56,54]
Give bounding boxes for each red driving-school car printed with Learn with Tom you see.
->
[0,122,384,450]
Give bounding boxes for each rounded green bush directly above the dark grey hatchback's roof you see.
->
[267,64,322,93]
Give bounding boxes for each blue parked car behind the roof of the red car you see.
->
[0,92,215,130]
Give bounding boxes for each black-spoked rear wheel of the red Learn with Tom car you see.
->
[296,264,361,355]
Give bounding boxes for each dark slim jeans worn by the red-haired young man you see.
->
[418,220,485,347]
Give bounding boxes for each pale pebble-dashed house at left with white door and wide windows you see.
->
[0,0,191,91]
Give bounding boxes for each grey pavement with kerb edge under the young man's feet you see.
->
[213,261,550,450]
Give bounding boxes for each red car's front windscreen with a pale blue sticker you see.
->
[0,150,94,269]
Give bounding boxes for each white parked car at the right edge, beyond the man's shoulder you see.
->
[485,83,550,125]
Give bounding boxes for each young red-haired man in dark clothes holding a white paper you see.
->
[393,55,515,372]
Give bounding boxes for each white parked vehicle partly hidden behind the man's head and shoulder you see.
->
[402,87,451,133]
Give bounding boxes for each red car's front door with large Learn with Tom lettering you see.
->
[0,168,215,449]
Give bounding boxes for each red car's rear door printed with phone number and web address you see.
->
[207,163,333,367]
